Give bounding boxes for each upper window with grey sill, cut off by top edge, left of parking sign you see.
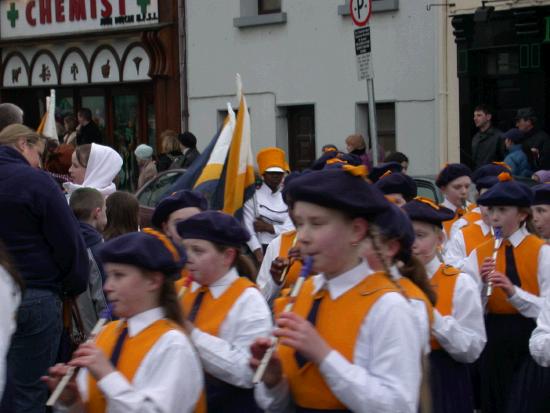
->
[233,0,286,29]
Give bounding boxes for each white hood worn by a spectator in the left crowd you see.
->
[63,143,122,197]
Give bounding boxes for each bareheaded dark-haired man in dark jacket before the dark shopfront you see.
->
[472,104,504,169]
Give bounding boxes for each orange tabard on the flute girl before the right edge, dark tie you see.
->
[476,234,544,314]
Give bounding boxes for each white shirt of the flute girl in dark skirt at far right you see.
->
[463,227,550,318]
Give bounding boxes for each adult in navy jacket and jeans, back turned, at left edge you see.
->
[0,125,88,413]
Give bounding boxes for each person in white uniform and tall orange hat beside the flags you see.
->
[244,148,294,263]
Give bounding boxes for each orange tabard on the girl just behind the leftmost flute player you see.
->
[181,277,254,336]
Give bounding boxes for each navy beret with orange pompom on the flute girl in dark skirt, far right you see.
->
[477,174,533,207]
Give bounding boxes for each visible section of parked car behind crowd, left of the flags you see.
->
[136,169,185,228]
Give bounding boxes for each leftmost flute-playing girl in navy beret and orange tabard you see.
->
[44,230,203,413]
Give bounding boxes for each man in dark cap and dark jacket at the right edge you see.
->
[516,108,550,171]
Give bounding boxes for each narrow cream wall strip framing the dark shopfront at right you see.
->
[439,0,550,162]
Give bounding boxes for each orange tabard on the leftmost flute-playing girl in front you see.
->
[86,319,181,413]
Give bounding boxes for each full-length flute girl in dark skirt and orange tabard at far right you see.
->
[464,173,550,413]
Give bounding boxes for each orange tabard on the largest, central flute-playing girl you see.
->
[278,273,399,410]
